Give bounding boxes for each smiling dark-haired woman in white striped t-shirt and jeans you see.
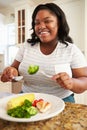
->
[1,3,87,102]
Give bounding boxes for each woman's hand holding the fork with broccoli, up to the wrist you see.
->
[52,72,73,90]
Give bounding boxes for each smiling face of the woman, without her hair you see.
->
[34,9,58,43]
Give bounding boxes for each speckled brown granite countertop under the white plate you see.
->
[0,102,87,130]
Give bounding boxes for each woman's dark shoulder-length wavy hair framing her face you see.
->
[27,3,73,45]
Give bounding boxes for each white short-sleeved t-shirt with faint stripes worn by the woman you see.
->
[16,43,87,98]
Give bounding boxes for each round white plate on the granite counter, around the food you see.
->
[0,93,65,122]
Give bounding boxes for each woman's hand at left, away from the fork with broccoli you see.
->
[1,67,18,82]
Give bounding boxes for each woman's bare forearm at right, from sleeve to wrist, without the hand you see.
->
[71,67,87,93]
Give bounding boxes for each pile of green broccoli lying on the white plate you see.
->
[7,99,38,118]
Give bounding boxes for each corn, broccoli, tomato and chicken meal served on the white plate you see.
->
[7,93,51,118]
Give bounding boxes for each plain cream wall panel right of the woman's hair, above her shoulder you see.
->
[56,0,85,51]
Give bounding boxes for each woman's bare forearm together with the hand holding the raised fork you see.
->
[52,67,87,93]
